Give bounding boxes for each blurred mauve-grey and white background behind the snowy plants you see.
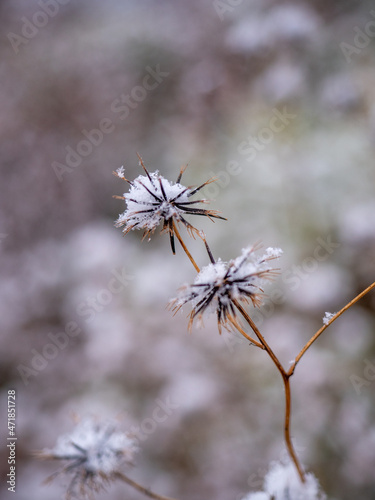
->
[0,0,375,500]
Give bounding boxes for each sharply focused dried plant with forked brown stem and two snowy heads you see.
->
[112,157,375,496]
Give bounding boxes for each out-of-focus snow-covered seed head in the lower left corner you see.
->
[37,418,137,499]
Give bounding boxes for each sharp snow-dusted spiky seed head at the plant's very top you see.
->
[114,156,225,253]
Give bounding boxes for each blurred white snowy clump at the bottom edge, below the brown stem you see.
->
[243,462,327,500]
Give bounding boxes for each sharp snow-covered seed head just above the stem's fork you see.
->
[171,245,282,331]
